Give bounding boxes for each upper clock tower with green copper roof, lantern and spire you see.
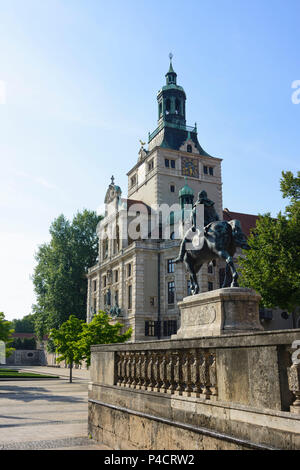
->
[127,55,222,217]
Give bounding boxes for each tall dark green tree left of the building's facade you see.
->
[33,210,101,339]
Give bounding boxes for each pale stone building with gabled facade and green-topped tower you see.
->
[87,62,222,341]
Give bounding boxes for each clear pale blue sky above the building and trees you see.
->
[0,0,300,319]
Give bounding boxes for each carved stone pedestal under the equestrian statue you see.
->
[171,287,263,339]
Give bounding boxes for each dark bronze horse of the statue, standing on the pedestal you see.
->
[183,220,250,295]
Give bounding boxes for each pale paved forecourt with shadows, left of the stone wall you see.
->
[0,367,108,450]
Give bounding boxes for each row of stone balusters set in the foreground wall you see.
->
[115,348,218,399]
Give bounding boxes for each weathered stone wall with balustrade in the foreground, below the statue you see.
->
[89,330,300,450]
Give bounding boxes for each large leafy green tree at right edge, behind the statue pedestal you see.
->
[239,172,300,313]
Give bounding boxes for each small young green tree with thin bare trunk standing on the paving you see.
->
[50,315,84,383]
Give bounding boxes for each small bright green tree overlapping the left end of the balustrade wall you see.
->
[79,311,132,366]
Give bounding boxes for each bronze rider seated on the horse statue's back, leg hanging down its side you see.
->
[174,190,220,263]
